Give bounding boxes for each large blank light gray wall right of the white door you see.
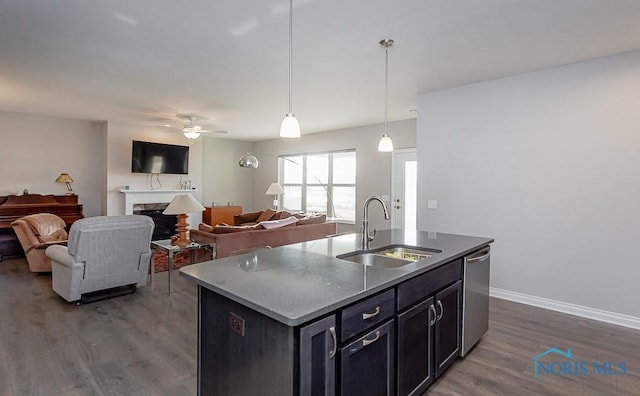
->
[417,52,640,317]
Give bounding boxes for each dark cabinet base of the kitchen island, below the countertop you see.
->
[198,260,462,396]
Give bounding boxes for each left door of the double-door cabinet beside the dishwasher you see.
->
[398,297,436,396]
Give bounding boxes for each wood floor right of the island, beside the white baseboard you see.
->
[425,298,640,396]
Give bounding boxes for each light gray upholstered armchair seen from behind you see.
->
[45,215,154,302]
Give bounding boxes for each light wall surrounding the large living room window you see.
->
[246,119,416,232]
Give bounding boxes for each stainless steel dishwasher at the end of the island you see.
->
[461,246,491,356]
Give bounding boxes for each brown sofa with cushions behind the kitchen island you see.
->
[190,210,336,261]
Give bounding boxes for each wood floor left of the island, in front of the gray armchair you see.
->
[0,259,197,396]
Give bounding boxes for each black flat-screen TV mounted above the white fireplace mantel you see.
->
[131,140,189,175]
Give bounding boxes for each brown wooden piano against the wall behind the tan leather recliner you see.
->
[0,194,84,260]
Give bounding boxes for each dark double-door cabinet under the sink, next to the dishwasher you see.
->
[397,261,462,395]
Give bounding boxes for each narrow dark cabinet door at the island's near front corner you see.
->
[300,315,338,396]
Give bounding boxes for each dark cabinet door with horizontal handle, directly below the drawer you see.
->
[340,320,395,396]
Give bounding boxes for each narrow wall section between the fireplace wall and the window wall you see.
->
[202,136,254,211]
